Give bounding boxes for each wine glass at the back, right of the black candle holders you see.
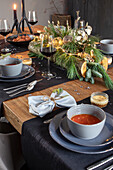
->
[28,11,38,33]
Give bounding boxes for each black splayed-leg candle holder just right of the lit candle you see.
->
[19,0,33,34]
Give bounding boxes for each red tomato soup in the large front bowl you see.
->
[71,114,100,125]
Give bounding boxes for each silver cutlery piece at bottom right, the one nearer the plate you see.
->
[87,155,113,170]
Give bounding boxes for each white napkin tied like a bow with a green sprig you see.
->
[28,88,76,117]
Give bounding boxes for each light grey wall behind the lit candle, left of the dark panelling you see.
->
[0,0,65,25]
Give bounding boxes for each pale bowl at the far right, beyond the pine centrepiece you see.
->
[100,39,113,54]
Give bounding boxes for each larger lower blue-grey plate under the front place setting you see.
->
[49,111,113,154]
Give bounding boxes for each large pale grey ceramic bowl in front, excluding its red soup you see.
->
[67,104,106,139]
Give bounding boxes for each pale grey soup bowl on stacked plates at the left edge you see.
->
[0,58,23,77]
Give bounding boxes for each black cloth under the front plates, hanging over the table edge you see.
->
[21,90,113,170]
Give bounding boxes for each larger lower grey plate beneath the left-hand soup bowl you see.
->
[0,66,35,82]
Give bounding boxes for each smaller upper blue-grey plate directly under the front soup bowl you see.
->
[59,113,113,147]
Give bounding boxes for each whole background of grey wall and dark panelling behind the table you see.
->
[0,0,113,38]
